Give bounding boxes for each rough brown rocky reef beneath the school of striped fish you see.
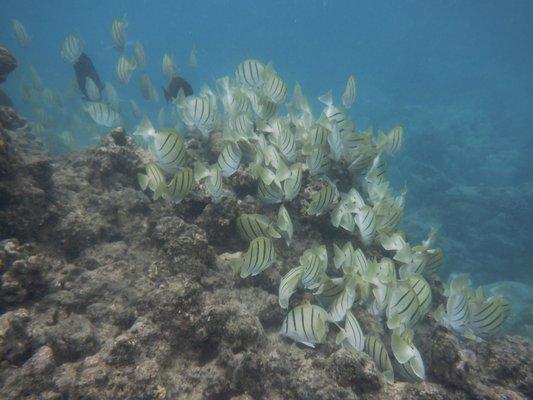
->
[0,108,533,400]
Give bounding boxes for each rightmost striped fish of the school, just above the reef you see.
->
[469,297,509,339]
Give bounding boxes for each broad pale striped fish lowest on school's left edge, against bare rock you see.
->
[280,304,328,347]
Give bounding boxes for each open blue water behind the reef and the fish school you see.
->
[0,0,533,285]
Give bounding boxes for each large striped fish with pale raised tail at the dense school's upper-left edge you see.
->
[133,117,189,174]
